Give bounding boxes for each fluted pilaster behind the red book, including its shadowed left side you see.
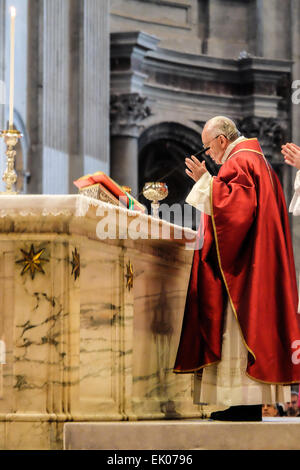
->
[69,0,110,192]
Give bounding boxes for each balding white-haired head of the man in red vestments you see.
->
[202,116,240,163]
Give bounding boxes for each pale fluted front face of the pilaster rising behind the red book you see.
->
[82,0,110,180]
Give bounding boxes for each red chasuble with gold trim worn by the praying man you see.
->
[174,139,300,384]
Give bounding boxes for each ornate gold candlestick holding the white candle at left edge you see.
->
[1,129,22,195]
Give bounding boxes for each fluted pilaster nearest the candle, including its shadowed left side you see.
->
[27,0,70,194]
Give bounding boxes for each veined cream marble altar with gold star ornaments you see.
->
[0,196,201,449]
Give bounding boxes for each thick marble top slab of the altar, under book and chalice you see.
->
[0,195,196,245]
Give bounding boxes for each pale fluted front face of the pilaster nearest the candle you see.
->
[43,0,71,194]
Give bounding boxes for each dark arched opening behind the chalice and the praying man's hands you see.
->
[139,122,202,228]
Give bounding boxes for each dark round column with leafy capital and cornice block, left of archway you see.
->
[110,32,158,197]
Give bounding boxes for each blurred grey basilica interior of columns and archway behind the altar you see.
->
[0,0,300,450]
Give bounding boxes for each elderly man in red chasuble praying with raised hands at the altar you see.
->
[174,116,300,421]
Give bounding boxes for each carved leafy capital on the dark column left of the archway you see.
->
[110,93,151,137]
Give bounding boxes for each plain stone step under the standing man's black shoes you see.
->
[64,418,300,450]
